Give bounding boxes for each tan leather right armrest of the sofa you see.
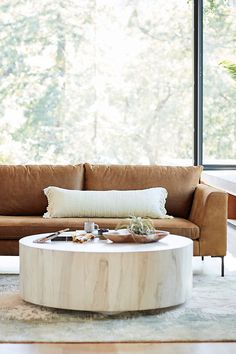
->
[189,184,228,256]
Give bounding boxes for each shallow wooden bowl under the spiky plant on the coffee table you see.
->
[103,229,169,243]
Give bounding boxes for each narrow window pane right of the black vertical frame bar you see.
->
[203,0,236,165]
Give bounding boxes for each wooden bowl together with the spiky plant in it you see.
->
[103,216,169,243]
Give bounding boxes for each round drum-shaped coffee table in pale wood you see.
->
[20,234,193,312]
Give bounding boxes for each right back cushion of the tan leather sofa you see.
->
[84,163,202,218]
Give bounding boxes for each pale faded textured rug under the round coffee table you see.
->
[0,275,236,342]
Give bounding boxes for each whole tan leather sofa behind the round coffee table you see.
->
[0,163,227,272]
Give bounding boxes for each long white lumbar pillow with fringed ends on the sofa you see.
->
[43,187,168,218]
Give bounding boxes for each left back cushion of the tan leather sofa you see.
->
[0,164,84,215]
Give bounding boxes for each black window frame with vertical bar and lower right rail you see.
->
[193,0,236,170]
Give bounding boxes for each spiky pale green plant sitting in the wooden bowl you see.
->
[116,216,155,235]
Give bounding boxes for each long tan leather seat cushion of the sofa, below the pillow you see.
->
[0,216,199,240]
